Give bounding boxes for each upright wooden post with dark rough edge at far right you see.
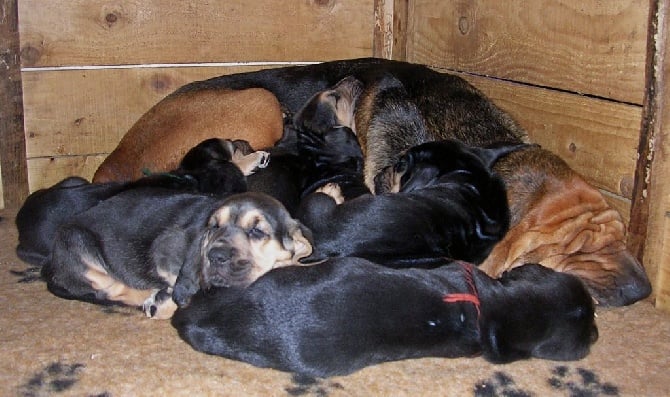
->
[644,0,670,312]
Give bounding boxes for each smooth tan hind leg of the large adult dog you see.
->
[93,88,283,182]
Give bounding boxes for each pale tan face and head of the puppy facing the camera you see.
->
[201,192,312,289]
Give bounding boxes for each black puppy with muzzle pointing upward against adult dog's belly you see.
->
[247,77,368,210]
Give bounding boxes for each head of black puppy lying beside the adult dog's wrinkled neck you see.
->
[375,139,525,194]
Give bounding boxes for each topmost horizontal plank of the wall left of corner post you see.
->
[19,0,373,66]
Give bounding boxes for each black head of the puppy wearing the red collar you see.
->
[478,264,598,363]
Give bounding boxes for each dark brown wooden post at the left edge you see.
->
[0,0,28,208]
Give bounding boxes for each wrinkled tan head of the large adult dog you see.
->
[480,149,651,306]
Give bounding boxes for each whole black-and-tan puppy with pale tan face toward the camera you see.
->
[42,187,311,319]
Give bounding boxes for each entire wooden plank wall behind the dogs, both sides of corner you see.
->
[5,0,670,309]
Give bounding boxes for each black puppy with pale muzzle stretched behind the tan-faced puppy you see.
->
[16,139,268,266]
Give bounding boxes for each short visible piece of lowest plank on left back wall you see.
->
[28,155,107,192]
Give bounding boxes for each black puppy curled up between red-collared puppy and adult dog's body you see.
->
[298,140,519,267]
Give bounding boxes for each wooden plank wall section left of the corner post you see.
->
[18,0,374,191]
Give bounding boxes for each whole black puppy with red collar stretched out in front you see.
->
[172,258,598,377]
